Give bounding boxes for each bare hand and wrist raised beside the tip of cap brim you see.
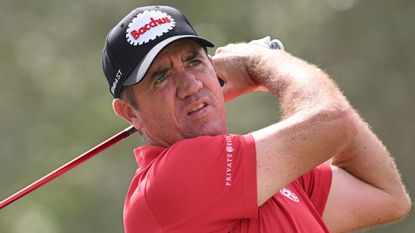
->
[212,44,274,101]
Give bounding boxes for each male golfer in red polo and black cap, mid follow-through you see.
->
[102,6,411,233]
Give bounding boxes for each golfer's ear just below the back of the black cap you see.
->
[112,99,141,130]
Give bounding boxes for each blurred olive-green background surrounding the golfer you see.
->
[0,0,415,233]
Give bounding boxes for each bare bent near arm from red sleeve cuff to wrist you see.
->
[253,55,356,205]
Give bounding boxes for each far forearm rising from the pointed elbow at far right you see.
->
[332,113,410,215]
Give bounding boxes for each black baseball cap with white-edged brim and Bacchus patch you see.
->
[102,6,214,98]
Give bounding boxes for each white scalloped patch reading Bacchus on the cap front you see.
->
[126,10,176,45]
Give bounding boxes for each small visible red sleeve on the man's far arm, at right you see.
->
[300,163,332,216]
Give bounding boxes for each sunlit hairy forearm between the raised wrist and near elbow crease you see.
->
[257,51,351,118]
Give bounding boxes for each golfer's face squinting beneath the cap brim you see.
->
[134,40,227,146]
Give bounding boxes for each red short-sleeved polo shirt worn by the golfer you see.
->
[124,135,331,233]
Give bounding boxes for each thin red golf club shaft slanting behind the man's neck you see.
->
[0,126,136,209]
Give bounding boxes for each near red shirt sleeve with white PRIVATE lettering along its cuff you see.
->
[145,135,257,232]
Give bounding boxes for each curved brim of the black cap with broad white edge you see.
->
[123,35,214,86]
